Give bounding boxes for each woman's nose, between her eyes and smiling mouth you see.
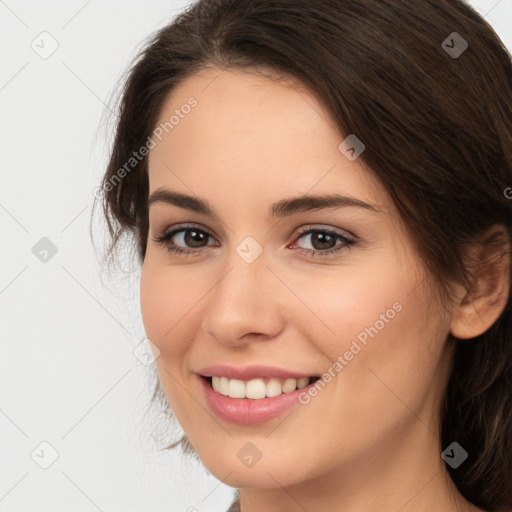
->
[203,249,285,347]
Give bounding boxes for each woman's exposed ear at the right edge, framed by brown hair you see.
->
[450,224,510,339]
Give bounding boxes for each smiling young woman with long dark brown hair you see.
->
[95,0,512,512]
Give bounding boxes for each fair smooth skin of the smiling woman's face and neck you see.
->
[141,69,508,512]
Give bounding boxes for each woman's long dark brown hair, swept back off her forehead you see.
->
[93,0,512,512]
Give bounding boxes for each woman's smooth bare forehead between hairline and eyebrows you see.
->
[149,69,386,212]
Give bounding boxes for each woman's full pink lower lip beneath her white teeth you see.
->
[199,377,315,425]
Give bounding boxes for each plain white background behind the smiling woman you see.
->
[0,0,512,512]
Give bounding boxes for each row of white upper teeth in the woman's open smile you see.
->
[212,377,312,400]
